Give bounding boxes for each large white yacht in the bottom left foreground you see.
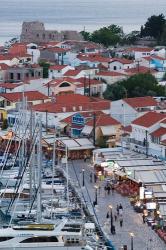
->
[0,219,94,250]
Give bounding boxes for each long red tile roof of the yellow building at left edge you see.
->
[0,91,48,102]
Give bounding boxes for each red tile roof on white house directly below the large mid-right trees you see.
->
[123,96,157,108]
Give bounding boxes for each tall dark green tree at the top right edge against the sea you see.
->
[141,14,166,39]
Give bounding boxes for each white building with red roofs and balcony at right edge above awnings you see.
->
[130,112,166,159]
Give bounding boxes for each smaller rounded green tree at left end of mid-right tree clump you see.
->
[103,83,127,101]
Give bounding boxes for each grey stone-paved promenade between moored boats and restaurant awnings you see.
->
[69,160,166,250]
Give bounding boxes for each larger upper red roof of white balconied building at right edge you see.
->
[132,112,166,128]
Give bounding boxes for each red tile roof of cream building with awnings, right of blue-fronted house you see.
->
[86,114,120,126]
